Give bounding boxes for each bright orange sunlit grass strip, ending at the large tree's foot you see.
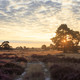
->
[0,50,62,57]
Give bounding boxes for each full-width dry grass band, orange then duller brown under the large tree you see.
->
[0,50,80,58]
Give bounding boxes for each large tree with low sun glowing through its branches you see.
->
[51,24,80,52]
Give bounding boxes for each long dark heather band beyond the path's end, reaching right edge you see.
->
[31,54,80,64]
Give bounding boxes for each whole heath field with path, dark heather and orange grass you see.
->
[0,50,80,80]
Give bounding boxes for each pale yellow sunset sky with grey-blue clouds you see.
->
[0,0,80,47]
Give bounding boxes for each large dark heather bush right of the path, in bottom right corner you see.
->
[50,65,80,80]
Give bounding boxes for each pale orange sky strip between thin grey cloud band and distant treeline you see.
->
[0,40,52,48]
